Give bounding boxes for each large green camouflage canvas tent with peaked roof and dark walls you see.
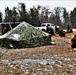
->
[0,22,51,48]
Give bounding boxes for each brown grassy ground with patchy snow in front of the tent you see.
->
[0,32,76,75]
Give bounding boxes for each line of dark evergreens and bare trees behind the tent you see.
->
[0,3,76,26]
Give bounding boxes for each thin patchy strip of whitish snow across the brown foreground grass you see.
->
[0,56,76,70]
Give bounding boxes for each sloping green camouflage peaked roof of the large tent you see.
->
[6,22,49,40]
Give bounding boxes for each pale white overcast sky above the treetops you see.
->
[0,0,76,13]
